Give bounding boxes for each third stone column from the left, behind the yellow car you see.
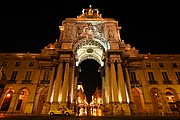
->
[61,60,69,106]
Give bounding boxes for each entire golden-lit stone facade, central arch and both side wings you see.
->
[0,6,180,115]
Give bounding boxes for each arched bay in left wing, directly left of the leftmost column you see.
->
[33,87,48,114]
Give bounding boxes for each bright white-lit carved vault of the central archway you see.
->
[73,38,109,66]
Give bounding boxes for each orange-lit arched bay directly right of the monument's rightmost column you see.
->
[132,87,145,114]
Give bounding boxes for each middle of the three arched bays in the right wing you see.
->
[150,88,165,114]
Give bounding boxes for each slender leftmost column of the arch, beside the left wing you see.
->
[42,66,56,114]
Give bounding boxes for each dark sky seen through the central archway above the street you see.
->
[78,59,102,103]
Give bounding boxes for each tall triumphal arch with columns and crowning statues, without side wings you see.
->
[42,6,138,115]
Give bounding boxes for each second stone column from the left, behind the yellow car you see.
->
[51,60,63,109]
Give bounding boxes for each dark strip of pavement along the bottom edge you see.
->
[0,115,180,120]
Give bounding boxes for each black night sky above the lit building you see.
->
[0,0,180,101]
